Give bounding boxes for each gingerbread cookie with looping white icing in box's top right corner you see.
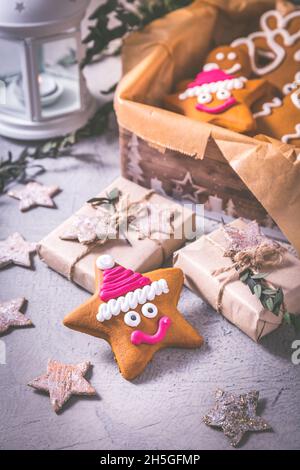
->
[231,9,300,94]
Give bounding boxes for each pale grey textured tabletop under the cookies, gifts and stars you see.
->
[0,1,300,449]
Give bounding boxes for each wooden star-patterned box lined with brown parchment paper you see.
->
[115,0,300,252]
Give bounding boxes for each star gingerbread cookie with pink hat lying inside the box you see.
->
[165,69,269,132]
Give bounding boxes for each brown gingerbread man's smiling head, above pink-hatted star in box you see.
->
[203,46,251,78]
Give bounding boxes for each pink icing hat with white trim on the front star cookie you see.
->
[96,255,169,322]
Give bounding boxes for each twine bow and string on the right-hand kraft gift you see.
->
[212,241,285,312]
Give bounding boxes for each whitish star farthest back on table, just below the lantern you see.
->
[8,181,60,212]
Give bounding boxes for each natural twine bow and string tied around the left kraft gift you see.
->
[68,190,174,281]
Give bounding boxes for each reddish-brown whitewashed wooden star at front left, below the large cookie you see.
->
[28,359,96,413]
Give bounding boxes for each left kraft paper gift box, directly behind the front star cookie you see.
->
[38,177,194,292]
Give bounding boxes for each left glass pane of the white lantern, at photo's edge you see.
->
[0,38,26,115]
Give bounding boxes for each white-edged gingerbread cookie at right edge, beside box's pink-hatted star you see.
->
[255,84,300,147]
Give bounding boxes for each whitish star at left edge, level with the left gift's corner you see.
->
[0,232,36,269]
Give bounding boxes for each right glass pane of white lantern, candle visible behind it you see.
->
[37,37,81,118]
